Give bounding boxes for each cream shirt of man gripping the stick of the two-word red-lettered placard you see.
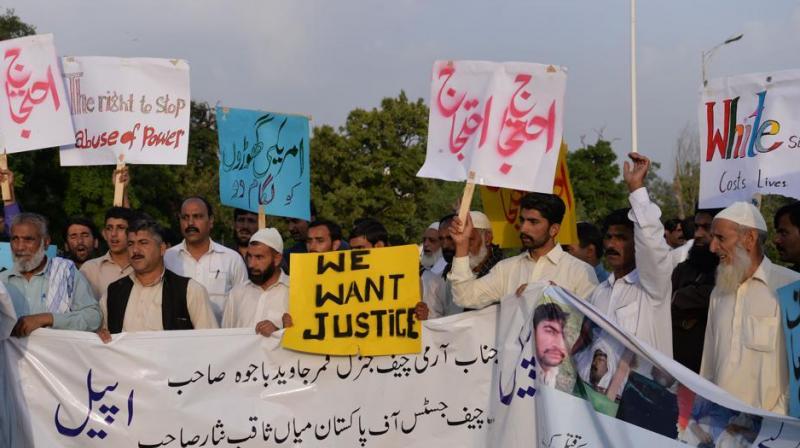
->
[447,244,597,308]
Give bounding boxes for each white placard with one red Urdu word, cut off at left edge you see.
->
[0,34,75,153]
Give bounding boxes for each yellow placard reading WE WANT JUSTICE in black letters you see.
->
[282,245,422,356]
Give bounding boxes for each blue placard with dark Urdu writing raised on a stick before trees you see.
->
[217,107,311,220]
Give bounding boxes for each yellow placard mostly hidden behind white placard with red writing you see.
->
[481,141,578,249]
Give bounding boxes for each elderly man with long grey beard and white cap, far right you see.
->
[700,202,800,414]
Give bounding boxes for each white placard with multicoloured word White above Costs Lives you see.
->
[698,70,800,208]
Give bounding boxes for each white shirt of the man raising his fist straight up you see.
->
[589,188,673,357]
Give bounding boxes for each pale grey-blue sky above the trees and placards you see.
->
[5,0,800,177]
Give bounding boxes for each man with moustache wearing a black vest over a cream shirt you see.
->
[98,219,218,342]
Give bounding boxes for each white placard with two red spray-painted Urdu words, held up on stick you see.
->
[417,61,567,193]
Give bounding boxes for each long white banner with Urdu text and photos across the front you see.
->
[0,284,800,448]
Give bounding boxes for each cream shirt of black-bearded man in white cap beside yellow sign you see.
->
[222,272,289,328]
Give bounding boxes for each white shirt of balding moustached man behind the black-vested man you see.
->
[164,240,247,324]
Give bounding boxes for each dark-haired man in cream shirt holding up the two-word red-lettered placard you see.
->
[443,193,597,308]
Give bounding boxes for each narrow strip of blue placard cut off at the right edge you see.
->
[778,280,800,417]
